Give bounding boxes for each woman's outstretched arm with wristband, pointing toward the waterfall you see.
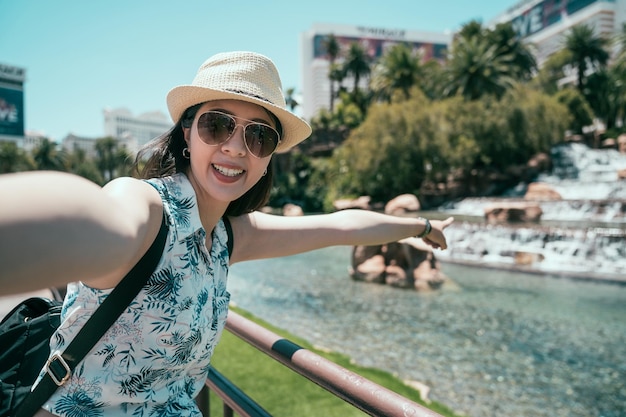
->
[231,210,454,263]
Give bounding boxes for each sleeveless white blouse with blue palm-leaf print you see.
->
[37,173,230,417]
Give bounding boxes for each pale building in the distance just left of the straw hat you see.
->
[104,108,173,152]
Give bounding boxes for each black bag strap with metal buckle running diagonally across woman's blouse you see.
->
[16,212,168,417]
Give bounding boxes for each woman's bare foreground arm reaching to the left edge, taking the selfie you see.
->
[0,171,162,294]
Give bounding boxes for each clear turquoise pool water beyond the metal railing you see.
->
[229,247,626,417]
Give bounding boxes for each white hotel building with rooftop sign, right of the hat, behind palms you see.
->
[300,24,452,119]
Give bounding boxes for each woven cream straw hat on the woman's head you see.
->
[167,51,311,152]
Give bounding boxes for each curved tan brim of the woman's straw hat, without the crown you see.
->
[167,85,311,152]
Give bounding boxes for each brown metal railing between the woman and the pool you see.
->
[198,311,441,417]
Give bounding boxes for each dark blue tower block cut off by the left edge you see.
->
[0,64,26,147]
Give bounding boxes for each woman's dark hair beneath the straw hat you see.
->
[134,103,282,216]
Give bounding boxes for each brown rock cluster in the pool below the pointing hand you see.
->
[350,238,445,291]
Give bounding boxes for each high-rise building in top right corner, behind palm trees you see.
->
[489,0,626,65]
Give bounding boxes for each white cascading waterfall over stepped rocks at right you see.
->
[437,143,626,283]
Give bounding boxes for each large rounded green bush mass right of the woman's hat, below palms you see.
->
[326,85,570,207]
